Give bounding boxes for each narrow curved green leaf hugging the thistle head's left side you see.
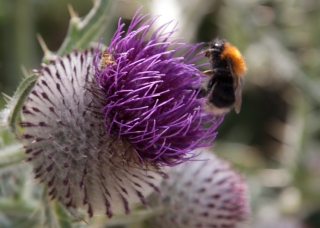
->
[5,74,39,134]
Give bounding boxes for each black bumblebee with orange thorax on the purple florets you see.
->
[199,38,247,115]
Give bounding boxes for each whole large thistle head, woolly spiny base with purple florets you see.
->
[20,12,222,217]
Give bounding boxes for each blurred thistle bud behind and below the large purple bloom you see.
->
[149,148,250,228]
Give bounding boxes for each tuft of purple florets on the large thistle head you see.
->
[95,11,222,166]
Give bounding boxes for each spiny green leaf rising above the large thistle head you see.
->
[57,0,116,56]
